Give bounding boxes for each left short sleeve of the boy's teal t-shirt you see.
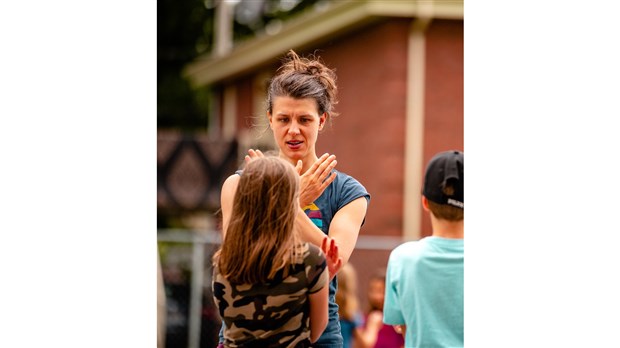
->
[383,248,405,325]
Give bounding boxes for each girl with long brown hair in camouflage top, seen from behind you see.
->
[213,157,338,347]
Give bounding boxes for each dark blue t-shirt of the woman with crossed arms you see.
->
[220,169,370,348]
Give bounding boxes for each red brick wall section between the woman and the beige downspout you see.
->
[317,19,409,235]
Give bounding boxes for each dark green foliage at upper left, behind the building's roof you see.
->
[157,0,326,131]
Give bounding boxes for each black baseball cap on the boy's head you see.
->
[422,150,464,209]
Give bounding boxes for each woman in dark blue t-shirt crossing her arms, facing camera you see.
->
[221,51,370,348]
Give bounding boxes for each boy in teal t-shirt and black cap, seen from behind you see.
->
[383,151,464,348]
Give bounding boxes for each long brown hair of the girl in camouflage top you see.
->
[214,156,299,284]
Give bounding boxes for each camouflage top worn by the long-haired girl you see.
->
[213,243,329,347]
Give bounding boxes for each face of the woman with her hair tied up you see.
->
[268,97,326,164]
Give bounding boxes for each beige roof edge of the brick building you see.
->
[182,0,463,88]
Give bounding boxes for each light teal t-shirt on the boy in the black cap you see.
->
[383,237,464,348]
